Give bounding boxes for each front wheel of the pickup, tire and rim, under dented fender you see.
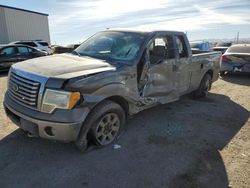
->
[75,100,126,151]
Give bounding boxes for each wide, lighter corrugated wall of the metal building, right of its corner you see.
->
[0,8,50,43]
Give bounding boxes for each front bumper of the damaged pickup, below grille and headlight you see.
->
[4,94,89,142]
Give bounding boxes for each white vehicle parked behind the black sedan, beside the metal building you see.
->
[10,40,52,55]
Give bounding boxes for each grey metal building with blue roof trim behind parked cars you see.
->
[0,5,50,44]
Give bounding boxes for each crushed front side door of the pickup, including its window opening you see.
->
[140,35,177,102]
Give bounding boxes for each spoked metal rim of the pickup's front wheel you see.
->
[96,113,120,145]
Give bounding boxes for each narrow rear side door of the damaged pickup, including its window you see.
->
[174,35,192,95]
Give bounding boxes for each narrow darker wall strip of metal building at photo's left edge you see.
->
[0,7,9,44]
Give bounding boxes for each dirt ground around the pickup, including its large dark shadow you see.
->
[0,74,250,188]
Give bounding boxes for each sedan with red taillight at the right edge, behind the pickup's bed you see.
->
[220,44,250,75]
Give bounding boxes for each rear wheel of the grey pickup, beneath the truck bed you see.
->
[193,73,212,98]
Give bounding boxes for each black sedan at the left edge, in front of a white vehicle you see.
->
[0,44,47,71]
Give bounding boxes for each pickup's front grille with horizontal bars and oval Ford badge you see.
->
[8,72,40,107]
